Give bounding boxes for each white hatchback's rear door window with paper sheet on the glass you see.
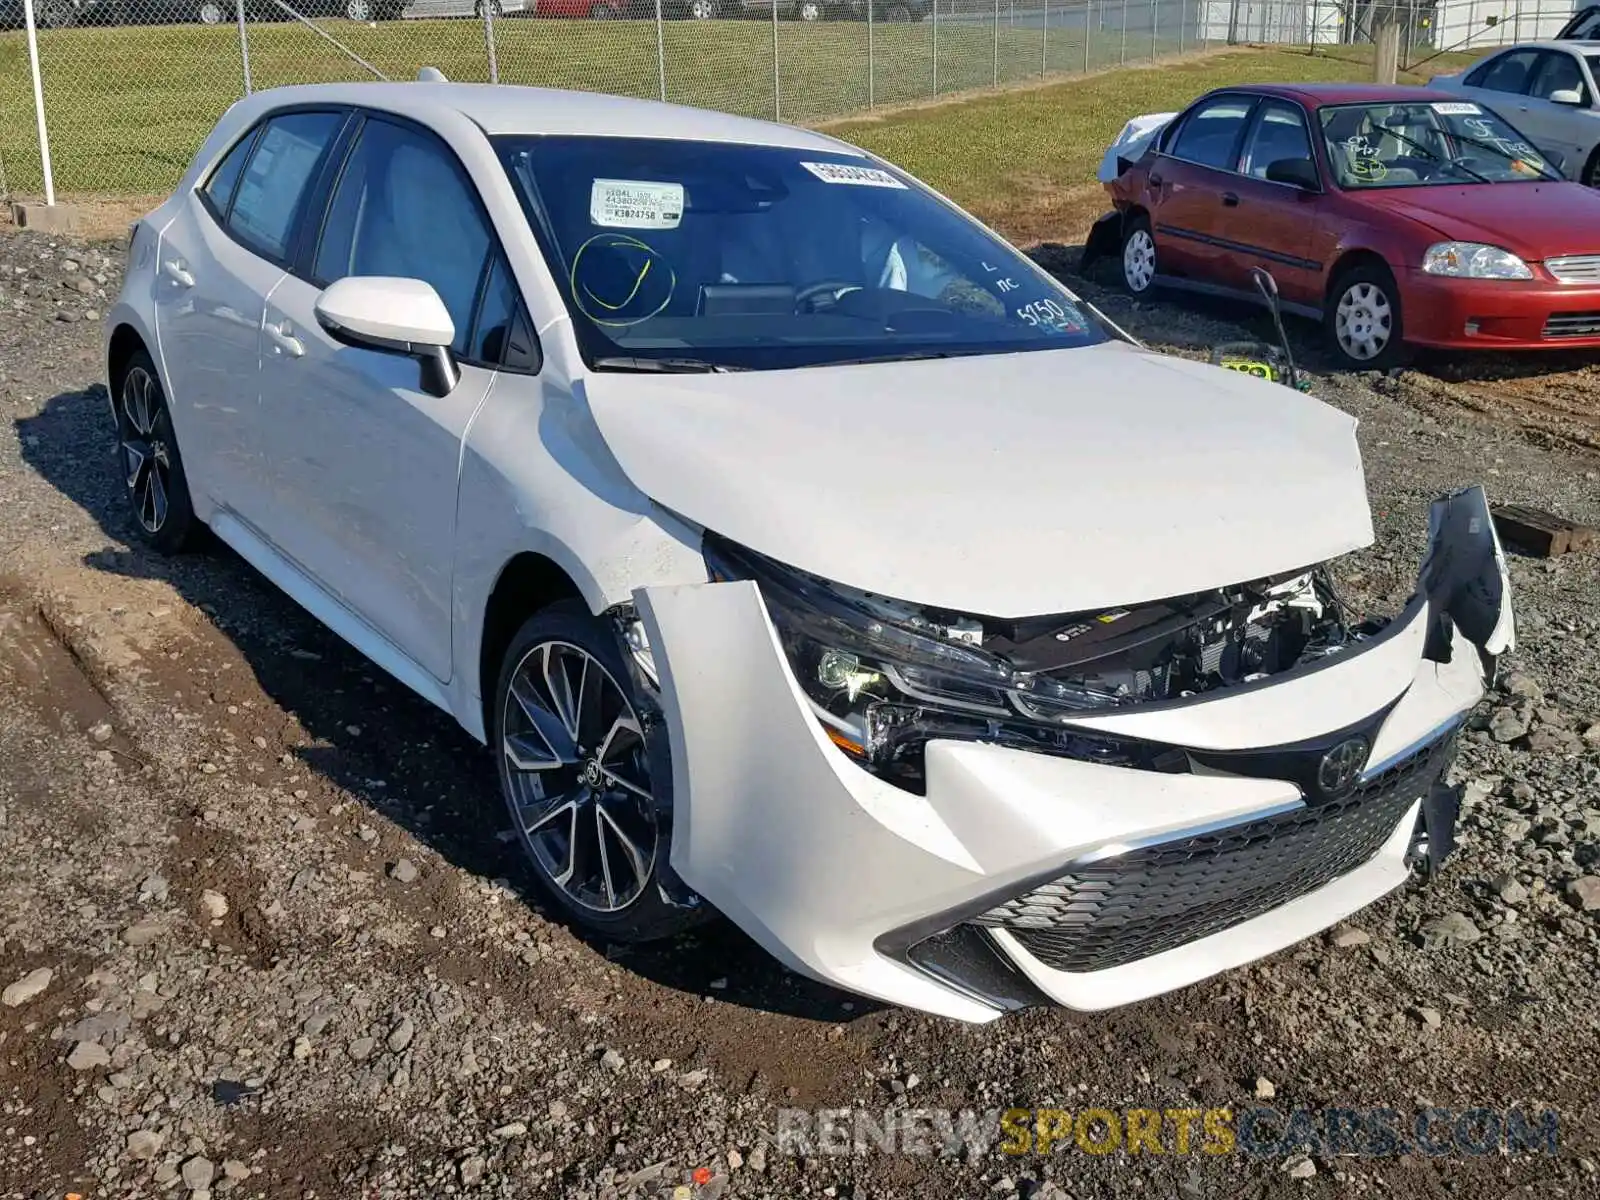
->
[227,112,344,262]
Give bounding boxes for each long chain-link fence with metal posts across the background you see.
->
[0,0,1574,197]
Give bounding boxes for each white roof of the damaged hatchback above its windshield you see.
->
[242,82,861,154]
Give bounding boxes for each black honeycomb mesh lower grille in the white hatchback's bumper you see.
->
[976,738,1454,971]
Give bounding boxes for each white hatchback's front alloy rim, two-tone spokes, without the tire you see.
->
[501,640,658,914]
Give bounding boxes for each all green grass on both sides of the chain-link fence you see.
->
[0,21,1472,232]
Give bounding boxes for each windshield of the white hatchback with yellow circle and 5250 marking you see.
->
[496,136,1107,371]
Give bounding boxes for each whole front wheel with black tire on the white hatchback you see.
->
[490,602,702,942]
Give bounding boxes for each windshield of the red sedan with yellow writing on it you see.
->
[1318,101,1560,187]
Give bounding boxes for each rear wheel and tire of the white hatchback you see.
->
[115,349,203,554]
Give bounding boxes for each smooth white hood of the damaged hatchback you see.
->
[576,342,1373,618]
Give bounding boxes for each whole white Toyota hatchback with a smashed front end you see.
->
[106,82,1512,1021]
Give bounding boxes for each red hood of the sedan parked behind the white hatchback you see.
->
[1363,181,1600,262]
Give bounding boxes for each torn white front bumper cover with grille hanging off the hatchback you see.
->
[637,488,1514,1021]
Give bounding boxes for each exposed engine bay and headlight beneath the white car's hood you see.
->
[706,541,1386,787]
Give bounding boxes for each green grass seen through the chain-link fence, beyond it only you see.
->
[0,21,1088,195]
